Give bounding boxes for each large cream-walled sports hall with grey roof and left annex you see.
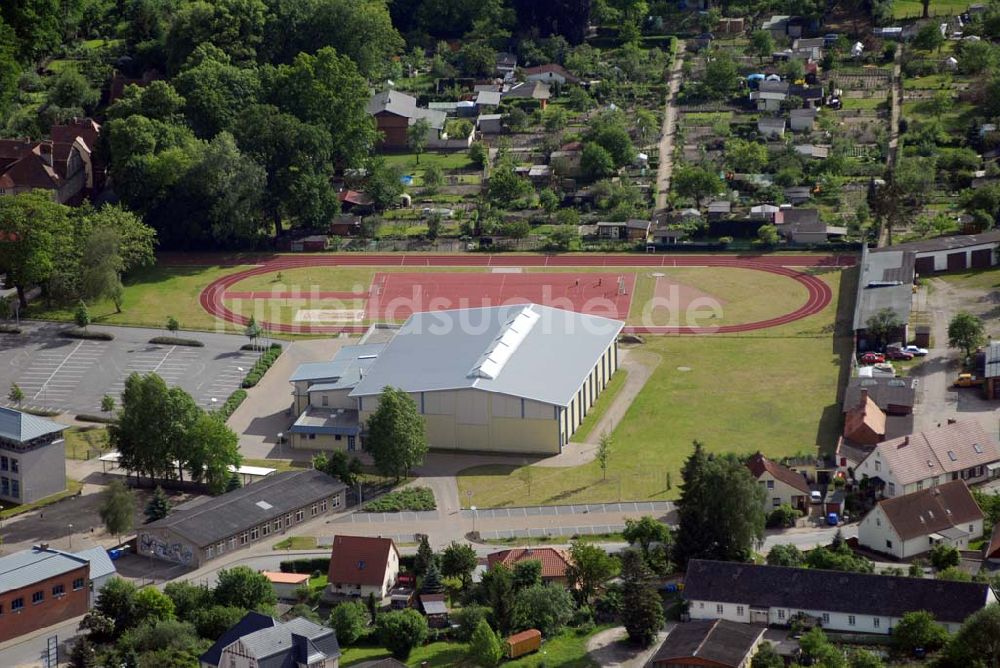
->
[289,304,623,455]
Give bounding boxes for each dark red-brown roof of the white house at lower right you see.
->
[878,480,983,540]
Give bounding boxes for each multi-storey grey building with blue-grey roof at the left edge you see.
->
[0,406,66,504]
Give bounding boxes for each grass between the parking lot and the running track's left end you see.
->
[28,266,254,336]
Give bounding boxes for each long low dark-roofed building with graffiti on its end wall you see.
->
[136,469,347,568]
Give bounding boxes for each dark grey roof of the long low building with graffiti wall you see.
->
[143,470,345,547]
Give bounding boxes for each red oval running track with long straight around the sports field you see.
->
[201,254,855,334]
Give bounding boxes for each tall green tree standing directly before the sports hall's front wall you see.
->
[365,387,427,480]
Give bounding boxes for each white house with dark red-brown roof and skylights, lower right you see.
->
[858,480,983,559]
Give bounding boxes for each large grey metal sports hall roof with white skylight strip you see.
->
[351,304,623,406]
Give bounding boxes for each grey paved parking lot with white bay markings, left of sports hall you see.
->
[0,323,257,413]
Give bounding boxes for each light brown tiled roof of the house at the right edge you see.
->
[869,420,1000,485]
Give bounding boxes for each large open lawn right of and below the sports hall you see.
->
[458,271,856,508]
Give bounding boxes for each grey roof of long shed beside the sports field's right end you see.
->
[854,250,914,331]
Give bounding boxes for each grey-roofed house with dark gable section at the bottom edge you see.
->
[199,612,340,668]
